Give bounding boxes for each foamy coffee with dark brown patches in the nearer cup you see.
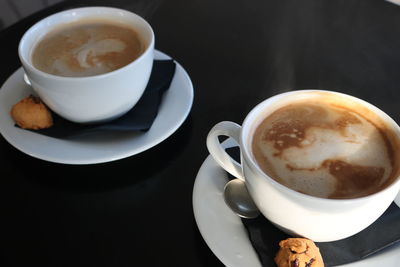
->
[252,99,397,199]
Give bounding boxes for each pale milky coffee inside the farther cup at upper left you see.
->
[32,20,145,77]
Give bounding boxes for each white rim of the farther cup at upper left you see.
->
[18,6,155,82]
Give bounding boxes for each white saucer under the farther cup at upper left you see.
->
[0,51,193,164]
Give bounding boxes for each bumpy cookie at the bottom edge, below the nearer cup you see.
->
[275,238,324,267]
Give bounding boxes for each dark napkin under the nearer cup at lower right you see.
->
[227,147,400,267]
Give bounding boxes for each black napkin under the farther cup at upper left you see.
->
[24,60,176,138]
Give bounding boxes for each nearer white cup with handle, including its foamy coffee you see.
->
[207,90,400,242]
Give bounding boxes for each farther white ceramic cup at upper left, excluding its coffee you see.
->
[18,7,154,123]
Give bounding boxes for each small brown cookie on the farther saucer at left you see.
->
[11,95,53,130]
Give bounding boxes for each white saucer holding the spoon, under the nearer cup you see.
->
[193,139,400,267]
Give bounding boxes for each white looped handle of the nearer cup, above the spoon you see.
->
[207,121,244,181]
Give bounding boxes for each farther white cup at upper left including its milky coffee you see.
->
[18,7,154,123]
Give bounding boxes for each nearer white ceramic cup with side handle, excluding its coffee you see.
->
[207,90,400,242]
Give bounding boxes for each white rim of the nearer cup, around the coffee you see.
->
[240,89,400,204]
